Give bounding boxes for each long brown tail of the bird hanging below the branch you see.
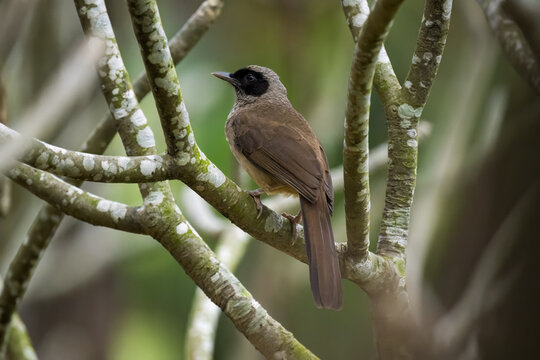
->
[300,188,343,310]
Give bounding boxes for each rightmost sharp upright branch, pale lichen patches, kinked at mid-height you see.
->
[377,0,452,260]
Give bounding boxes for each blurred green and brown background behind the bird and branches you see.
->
[0,0,540,360]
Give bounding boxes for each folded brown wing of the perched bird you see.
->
[232,110,326,203]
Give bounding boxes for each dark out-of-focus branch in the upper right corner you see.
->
[477,0,540,94]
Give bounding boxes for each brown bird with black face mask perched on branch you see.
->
[213,65,342,310]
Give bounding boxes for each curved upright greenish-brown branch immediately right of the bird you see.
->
[343,0,402,259]
